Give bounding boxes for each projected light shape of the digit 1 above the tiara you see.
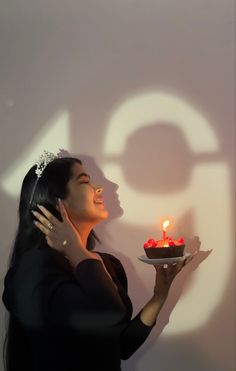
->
[0,109,70,197]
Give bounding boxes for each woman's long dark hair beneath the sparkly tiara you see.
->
[3,157,100,371]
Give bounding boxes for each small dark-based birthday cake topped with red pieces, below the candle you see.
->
[143,237,185,259]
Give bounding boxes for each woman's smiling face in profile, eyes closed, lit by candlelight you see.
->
[63,163,108,224]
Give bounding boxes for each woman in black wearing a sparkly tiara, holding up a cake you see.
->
[2,152,194,371]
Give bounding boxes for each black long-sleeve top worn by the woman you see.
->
[2,248,156,371]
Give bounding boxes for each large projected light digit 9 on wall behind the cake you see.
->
[100,92,232,335]
